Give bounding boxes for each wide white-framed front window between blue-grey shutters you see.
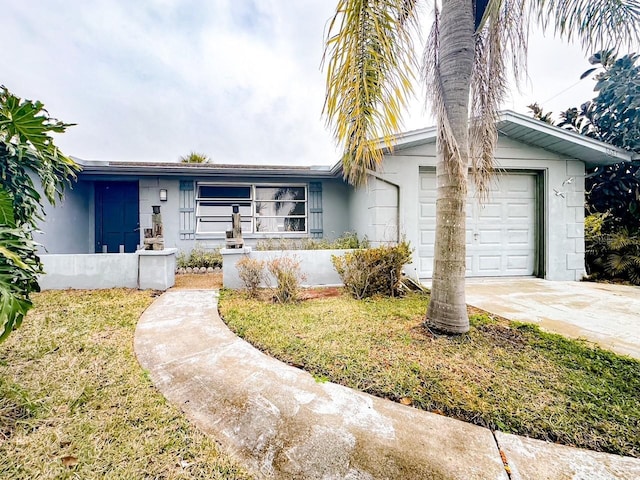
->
[196,183,307,235]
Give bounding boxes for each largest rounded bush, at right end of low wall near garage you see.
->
[331,241,412,299]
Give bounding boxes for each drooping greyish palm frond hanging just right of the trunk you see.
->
[469,0,528,202]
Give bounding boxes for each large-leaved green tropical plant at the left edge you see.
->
[0,86,79,341]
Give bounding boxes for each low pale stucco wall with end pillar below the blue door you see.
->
[38,248,178,290]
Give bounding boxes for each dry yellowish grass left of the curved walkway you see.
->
[0,290,248,479]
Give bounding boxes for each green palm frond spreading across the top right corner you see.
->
[531,0,640,51]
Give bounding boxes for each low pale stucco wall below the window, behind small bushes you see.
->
[220,247,349,289]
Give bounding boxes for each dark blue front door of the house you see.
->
[95,182,140,253]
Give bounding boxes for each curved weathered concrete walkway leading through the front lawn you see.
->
[134,290,640,480]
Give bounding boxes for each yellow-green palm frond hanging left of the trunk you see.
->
[322,0,417,185]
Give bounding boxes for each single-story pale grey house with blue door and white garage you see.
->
[38,111,631,280]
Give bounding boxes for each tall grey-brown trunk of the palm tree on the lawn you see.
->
[426,0,474,333]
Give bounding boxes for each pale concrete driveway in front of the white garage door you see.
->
[467,278,640,359]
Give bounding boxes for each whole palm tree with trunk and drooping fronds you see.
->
[323,0,640,333]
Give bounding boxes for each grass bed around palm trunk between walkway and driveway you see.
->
[220,291,640,457]
